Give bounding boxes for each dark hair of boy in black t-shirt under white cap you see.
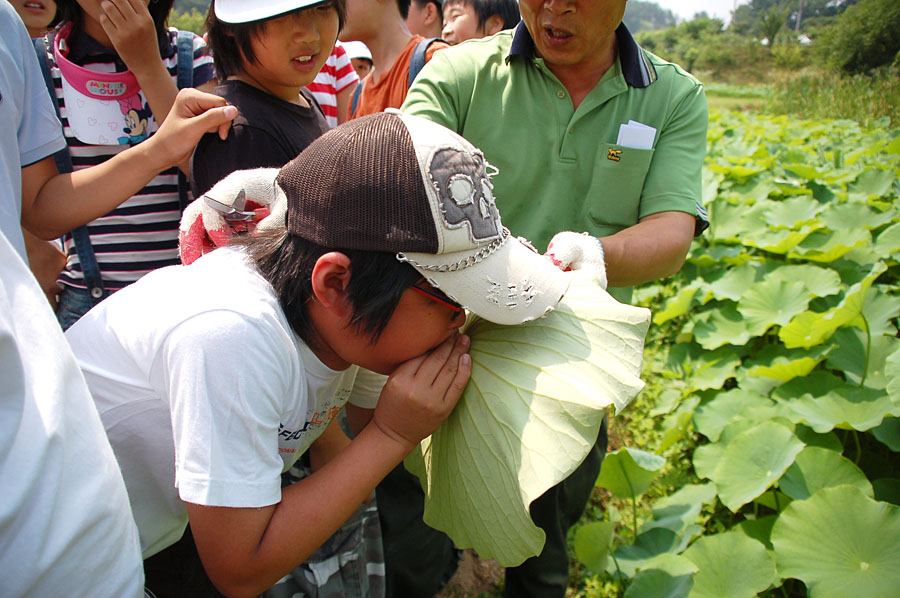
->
[206,0,346,81]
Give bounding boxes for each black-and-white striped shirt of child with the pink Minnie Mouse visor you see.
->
[47,28,215,290]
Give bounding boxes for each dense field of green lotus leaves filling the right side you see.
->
[578,112,900,598]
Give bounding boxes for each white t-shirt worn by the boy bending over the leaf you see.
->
[66,248,377,558]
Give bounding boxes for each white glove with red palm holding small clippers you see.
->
[178,168,279,265]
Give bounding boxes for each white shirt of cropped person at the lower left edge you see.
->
[0,232,144,598]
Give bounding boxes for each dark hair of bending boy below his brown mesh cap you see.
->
[239,228,422,346]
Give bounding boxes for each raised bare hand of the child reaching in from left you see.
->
[144,89,237,172]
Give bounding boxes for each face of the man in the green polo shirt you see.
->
[519,0,627,76]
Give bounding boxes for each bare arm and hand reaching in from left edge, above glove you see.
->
[22,89,237,240]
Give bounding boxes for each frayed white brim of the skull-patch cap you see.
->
[405,236,569,325]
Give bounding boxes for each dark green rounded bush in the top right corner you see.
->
[816,0,900,74]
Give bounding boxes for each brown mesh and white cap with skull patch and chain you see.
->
[276,112,569,324]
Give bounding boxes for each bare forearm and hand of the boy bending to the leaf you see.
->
[187,337,472,596]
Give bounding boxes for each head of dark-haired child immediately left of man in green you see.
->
[441,0,520,45]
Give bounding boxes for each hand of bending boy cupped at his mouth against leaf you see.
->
[373,335,472,452]
